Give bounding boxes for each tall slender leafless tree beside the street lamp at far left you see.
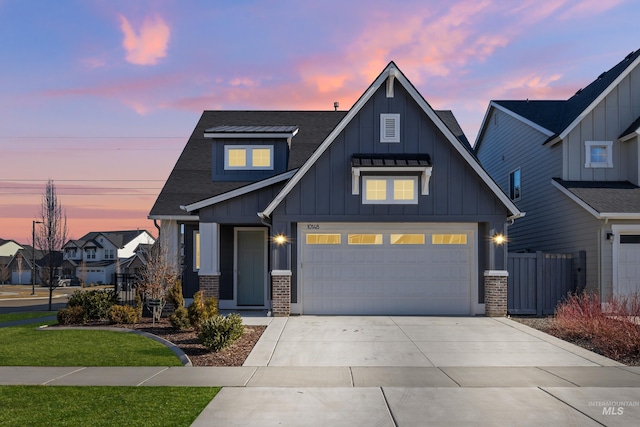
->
[33,179,67,310]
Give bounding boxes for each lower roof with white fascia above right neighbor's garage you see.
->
[552,178,640,219]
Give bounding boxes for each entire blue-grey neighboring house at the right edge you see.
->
[475,50,640,299]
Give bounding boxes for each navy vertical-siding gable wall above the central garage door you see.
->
[274,84,508,226]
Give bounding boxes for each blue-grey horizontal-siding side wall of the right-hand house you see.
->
[478,109,602,289]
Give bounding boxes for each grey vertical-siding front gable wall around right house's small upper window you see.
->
[561,67,640,184]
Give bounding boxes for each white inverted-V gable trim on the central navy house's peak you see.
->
[258,61,524,219]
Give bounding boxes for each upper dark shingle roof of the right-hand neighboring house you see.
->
[493,49,640,140]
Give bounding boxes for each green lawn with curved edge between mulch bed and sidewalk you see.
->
[0,324,181,368]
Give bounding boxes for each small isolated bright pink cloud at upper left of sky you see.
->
[120,15,171,65]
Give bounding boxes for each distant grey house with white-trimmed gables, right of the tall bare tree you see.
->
[62,230,155,284]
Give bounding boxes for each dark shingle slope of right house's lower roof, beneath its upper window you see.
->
[554,178,640,213]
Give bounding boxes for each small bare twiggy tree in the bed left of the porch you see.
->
[139,232,180,322]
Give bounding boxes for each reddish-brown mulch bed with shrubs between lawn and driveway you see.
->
[131,317,267,366]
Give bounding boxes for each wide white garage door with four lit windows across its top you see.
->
[299,223,477,315]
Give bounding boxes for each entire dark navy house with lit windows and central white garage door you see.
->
[149,62,522,315]
